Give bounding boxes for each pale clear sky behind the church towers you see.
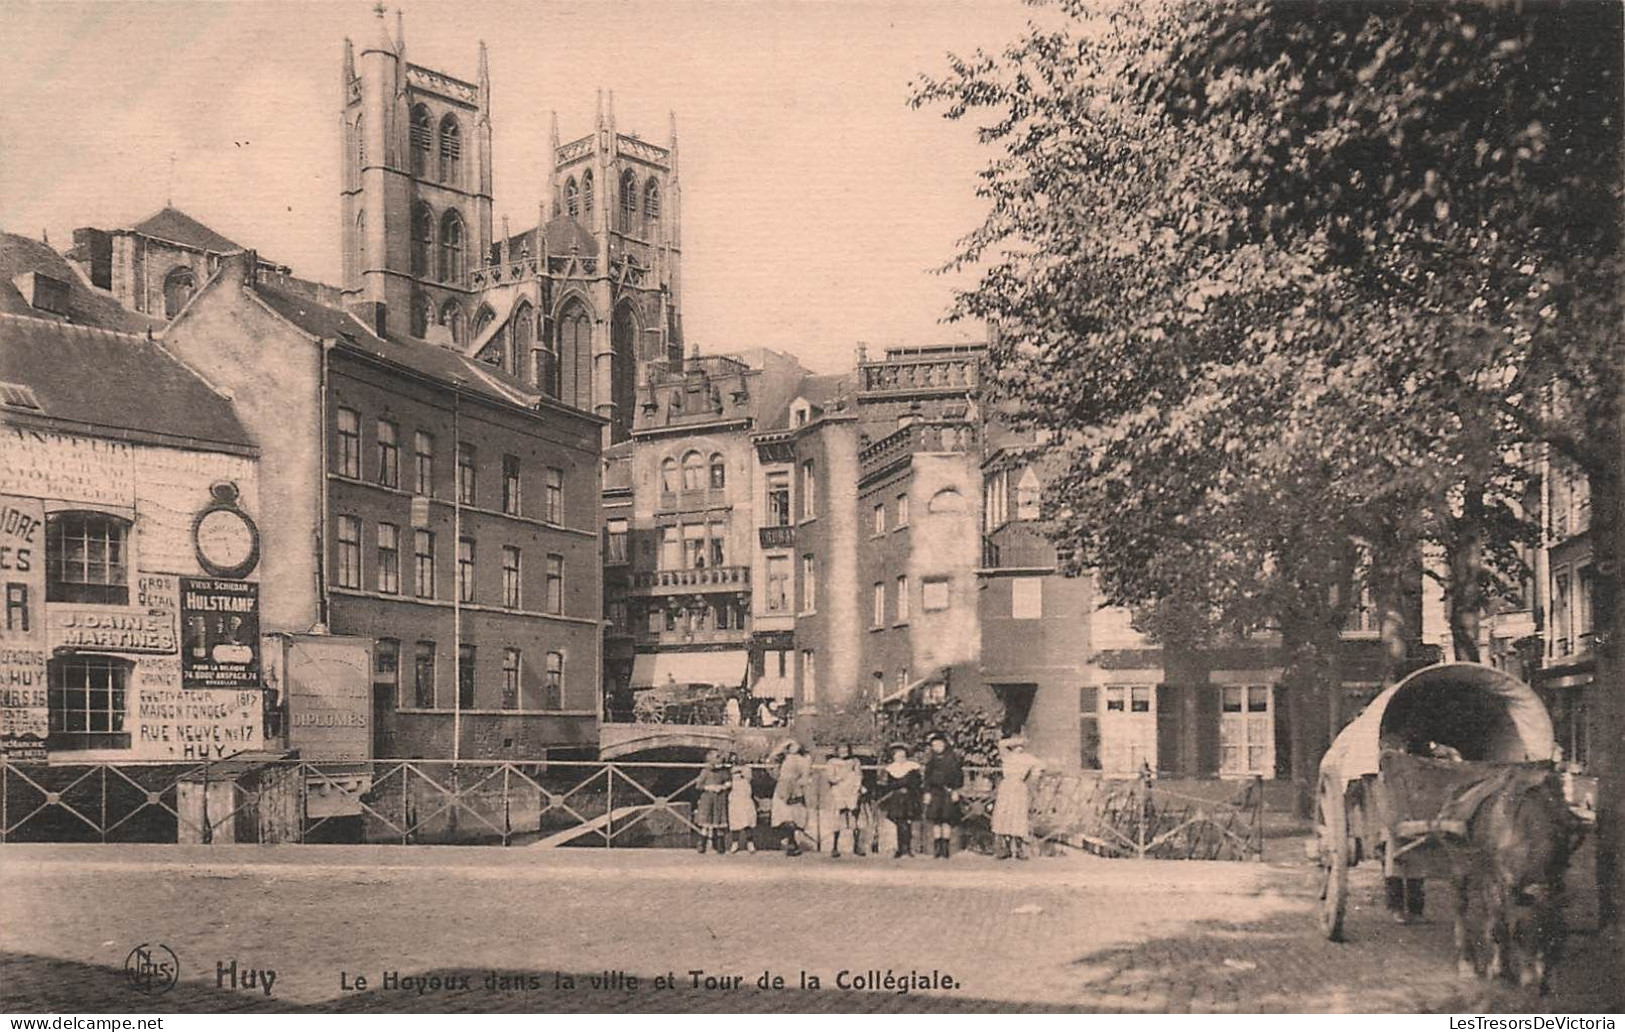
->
[0,0,1032,371]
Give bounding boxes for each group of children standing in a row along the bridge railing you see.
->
[694,735,1043,860]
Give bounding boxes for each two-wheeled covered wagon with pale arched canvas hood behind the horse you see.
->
[1311,663,1557,939]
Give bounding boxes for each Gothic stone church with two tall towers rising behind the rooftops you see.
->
[341,13,683,444]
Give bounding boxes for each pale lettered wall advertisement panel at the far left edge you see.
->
[0,496,50,761]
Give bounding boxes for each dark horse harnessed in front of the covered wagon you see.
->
[1446,765,1580,995]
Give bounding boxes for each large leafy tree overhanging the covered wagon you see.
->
[913,0,1622,903]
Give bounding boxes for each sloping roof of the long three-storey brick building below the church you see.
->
[254,283,552,406]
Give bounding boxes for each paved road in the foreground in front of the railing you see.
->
[0,845,1620,1012]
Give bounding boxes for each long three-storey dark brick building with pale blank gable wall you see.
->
[164,254,601,759]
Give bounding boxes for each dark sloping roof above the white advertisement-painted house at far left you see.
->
[0,308,254,449]
